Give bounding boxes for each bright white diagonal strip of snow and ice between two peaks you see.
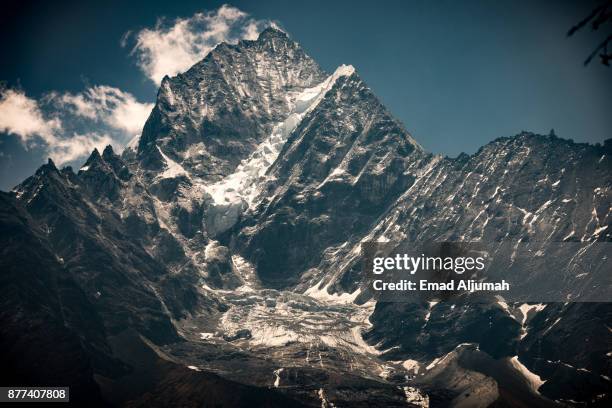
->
[206,65,355,207]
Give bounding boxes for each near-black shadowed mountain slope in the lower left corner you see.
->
[0,193,109,406]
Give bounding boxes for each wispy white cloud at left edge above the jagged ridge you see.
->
[0,86,153,164]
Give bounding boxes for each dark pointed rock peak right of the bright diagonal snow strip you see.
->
[238,66,430,287]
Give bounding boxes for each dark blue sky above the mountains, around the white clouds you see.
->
[0,0,612,190]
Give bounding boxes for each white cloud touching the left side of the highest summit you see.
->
[128,5,269,85]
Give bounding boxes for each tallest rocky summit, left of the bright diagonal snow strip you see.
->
[138,28,327,181]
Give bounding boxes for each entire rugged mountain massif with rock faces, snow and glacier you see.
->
[0,28,612,406]
